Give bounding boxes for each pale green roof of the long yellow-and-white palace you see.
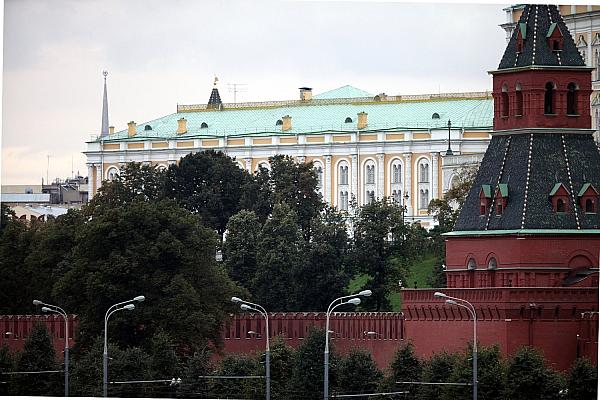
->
[97,86,493,142]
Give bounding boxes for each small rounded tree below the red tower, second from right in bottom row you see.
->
[505,347,562,400]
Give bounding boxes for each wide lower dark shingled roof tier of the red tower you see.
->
[454,133,600,231]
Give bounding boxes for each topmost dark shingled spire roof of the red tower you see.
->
[498,4,585,70]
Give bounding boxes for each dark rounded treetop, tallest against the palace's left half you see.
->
[165,150,249,238]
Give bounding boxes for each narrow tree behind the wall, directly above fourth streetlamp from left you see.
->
[289,208,351,311]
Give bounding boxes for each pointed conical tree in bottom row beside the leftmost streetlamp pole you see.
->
[11,323,64,396]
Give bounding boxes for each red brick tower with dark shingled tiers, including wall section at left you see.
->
[403,5,600,369]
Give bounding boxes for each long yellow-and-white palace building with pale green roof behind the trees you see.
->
[85,80,493,227]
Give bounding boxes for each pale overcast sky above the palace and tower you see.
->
[1,0,506,184]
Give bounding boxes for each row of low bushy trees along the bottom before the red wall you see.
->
[0,325,597,400]
